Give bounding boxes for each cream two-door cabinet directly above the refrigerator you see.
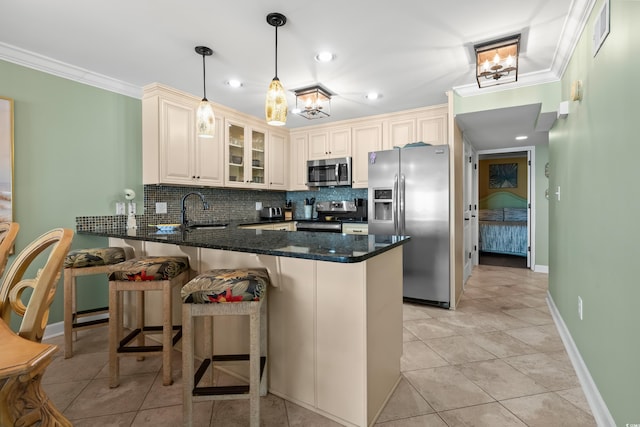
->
[383,106,448,150]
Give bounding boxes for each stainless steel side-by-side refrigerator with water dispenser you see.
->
[368,145,450,308]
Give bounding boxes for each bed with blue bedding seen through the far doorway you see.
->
[478,193,528,256]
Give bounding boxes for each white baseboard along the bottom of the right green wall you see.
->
[547,292,616,427]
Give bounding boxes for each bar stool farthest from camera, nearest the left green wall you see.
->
[64,247,131,359]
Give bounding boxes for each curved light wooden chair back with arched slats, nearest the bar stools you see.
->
[0,228,73,342]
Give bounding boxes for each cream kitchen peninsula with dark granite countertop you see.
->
[78,223,409,426]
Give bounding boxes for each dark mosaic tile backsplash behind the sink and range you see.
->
[76,185,367,230]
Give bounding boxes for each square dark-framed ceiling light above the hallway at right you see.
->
[473,34,520,88]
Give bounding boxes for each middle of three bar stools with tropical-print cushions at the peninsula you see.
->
[109,256,189,388]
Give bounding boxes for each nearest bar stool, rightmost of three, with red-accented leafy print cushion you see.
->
[181,268,270,427]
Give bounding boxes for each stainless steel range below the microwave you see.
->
[296,199,367,233]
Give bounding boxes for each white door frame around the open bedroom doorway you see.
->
[474,145,536,270]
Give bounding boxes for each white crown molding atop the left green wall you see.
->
[0,42,142,99]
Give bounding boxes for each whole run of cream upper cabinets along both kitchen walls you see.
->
[142,83,448,191]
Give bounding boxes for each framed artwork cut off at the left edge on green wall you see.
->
[0,96,14,222]
